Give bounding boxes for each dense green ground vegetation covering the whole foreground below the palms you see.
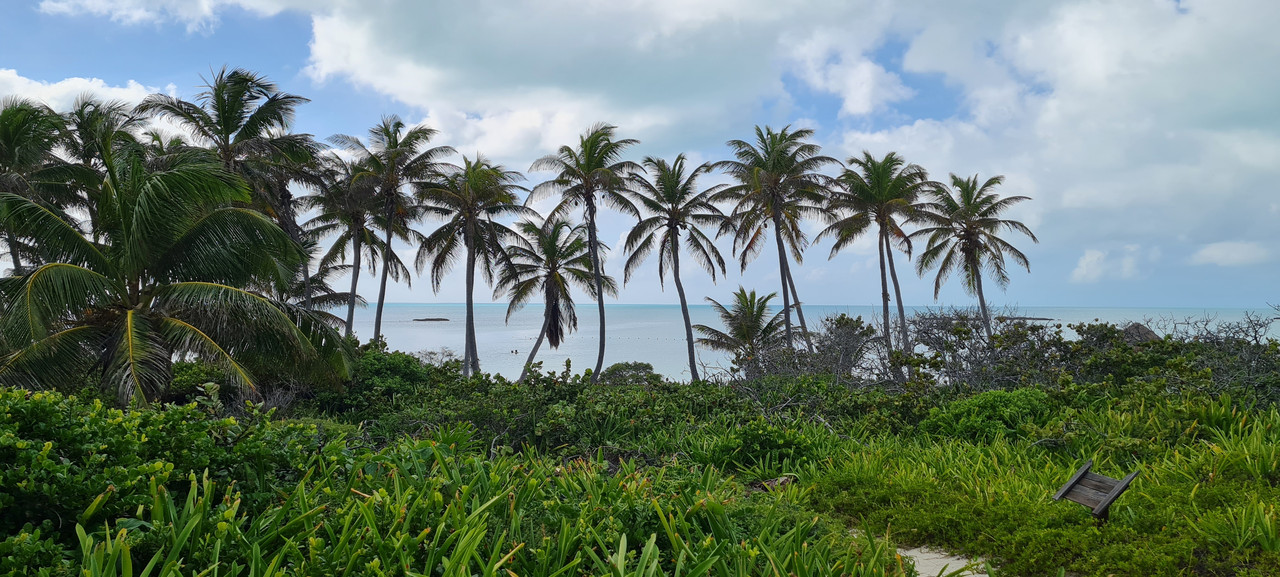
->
[0,320,1280,576]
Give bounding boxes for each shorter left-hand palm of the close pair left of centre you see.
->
[302,156,389,338]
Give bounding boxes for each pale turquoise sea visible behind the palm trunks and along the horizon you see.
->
[345,303,1276,380]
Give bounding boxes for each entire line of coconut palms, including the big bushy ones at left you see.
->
[0,69,1036,400]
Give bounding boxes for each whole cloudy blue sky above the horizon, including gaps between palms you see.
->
[0,0,1280,308]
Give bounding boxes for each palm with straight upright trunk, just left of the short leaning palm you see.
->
[416,155,538,376]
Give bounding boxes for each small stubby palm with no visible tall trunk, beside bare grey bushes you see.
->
[694,287,790,376]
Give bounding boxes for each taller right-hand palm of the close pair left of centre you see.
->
[329,115,453,340]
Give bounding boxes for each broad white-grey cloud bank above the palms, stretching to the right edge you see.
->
[17,0,1280,307]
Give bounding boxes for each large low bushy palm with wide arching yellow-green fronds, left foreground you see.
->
[0,137,349,403]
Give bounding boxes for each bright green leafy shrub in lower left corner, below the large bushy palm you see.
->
[0,389,319,568]
